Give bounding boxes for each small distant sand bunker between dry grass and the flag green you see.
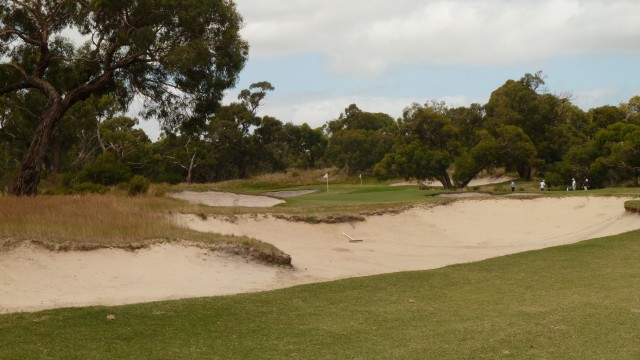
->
[167,191,285,207]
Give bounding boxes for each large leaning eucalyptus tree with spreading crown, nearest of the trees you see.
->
[0,0,248,195]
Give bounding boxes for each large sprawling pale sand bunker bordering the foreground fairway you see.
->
[0,197,640,313]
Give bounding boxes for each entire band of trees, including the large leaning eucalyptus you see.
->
[0,0,640,195]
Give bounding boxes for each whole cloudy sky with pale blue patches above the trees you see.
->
[141,0,640,139]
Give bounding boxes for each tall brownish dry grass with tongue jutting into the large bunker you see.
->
[0,194,291,264]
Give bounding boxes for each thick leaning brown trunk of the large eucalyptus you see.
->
[10,102,64,196]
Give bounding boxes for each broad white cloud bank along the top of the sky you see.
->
[236,0,640,77]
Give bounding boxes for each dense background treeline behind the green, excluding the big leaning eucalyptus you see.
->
[0,73,640,191]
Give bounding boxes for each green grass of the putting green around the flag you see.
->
[158,176,450,221]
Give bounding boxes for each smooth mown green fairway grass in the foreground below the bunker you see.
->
[0,232,640,360]
